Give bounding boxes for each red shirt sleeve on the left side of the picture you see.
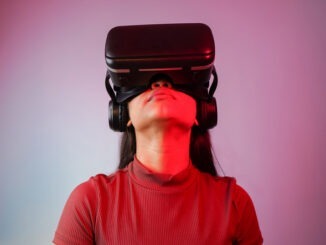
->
[53,181,97,245]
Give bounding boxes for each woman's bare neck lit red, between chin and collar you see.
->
[136,125,191,175]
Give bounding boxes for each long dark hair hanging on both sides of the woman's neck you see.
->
[118,126,218,176]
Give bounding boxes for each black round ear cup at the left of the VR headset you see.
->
[109,101,129,132]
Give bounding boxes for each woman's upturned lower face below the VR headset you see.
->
[128,80,196,131]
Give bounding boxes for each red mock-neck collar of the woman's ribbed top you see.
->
[128,157,198,192]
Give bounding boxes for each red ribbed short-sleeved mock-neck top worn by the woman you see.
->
[53,159,262,245]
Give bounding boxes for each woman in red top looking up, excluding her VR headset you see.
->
[54,23,262,244]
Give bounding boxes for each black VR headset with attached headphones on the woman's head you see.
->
[105,23,218,132]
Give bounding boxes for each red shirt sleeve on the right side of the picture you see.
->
[234,185,263,245]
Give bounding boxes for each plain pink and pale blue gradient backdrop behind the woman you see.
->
[0,0,326,245]
